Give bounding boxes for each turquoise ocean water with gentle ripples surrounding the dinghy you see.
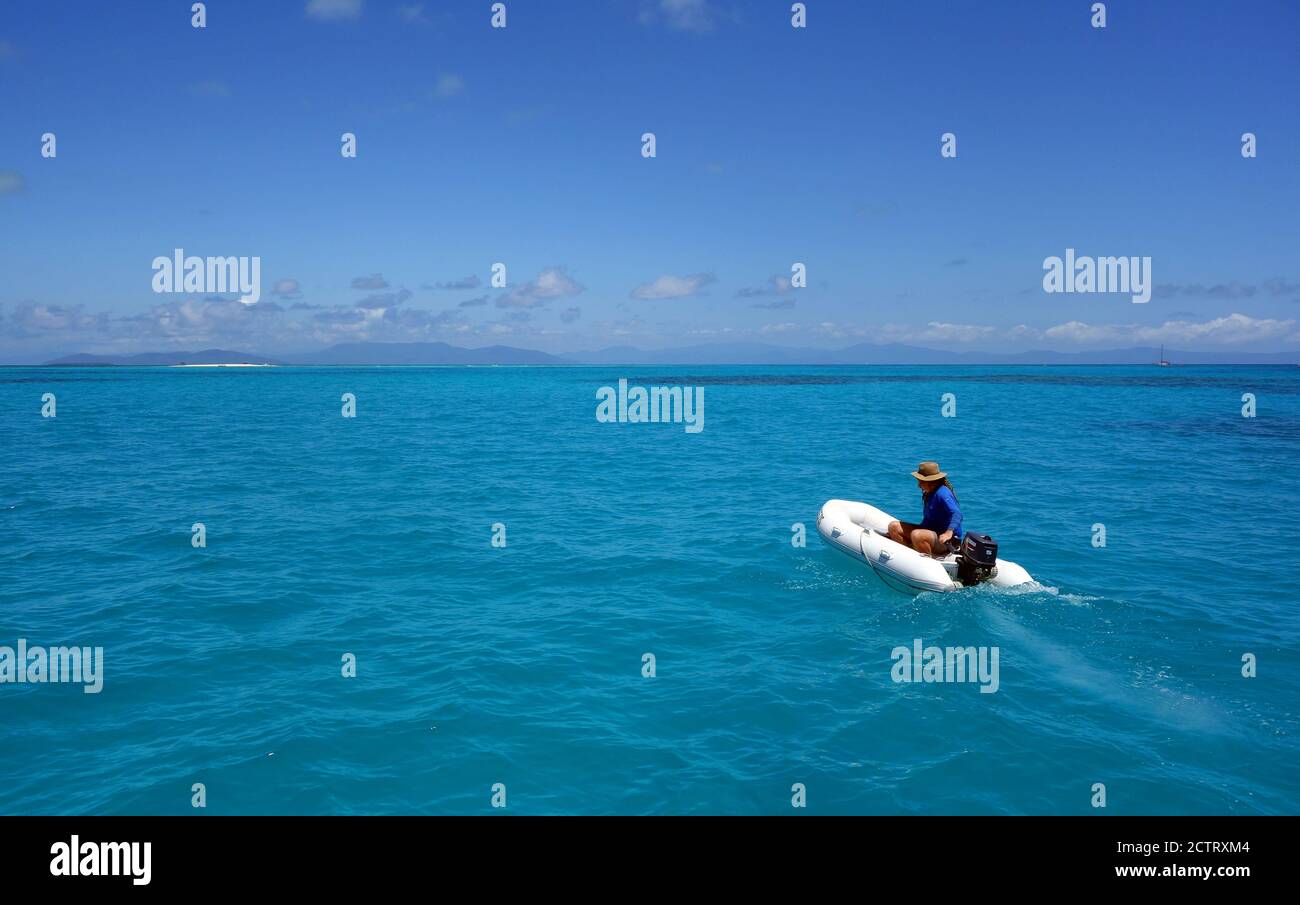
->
[0,367,1300,814]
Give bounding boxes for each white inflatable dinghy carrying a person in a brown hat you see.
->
[816,499,1034,594]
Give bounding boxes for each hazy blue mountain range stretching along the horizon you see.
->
[38,342,1300,367]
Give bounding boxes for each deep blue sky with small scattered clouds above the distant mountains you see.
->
[0,0,1300,361]
